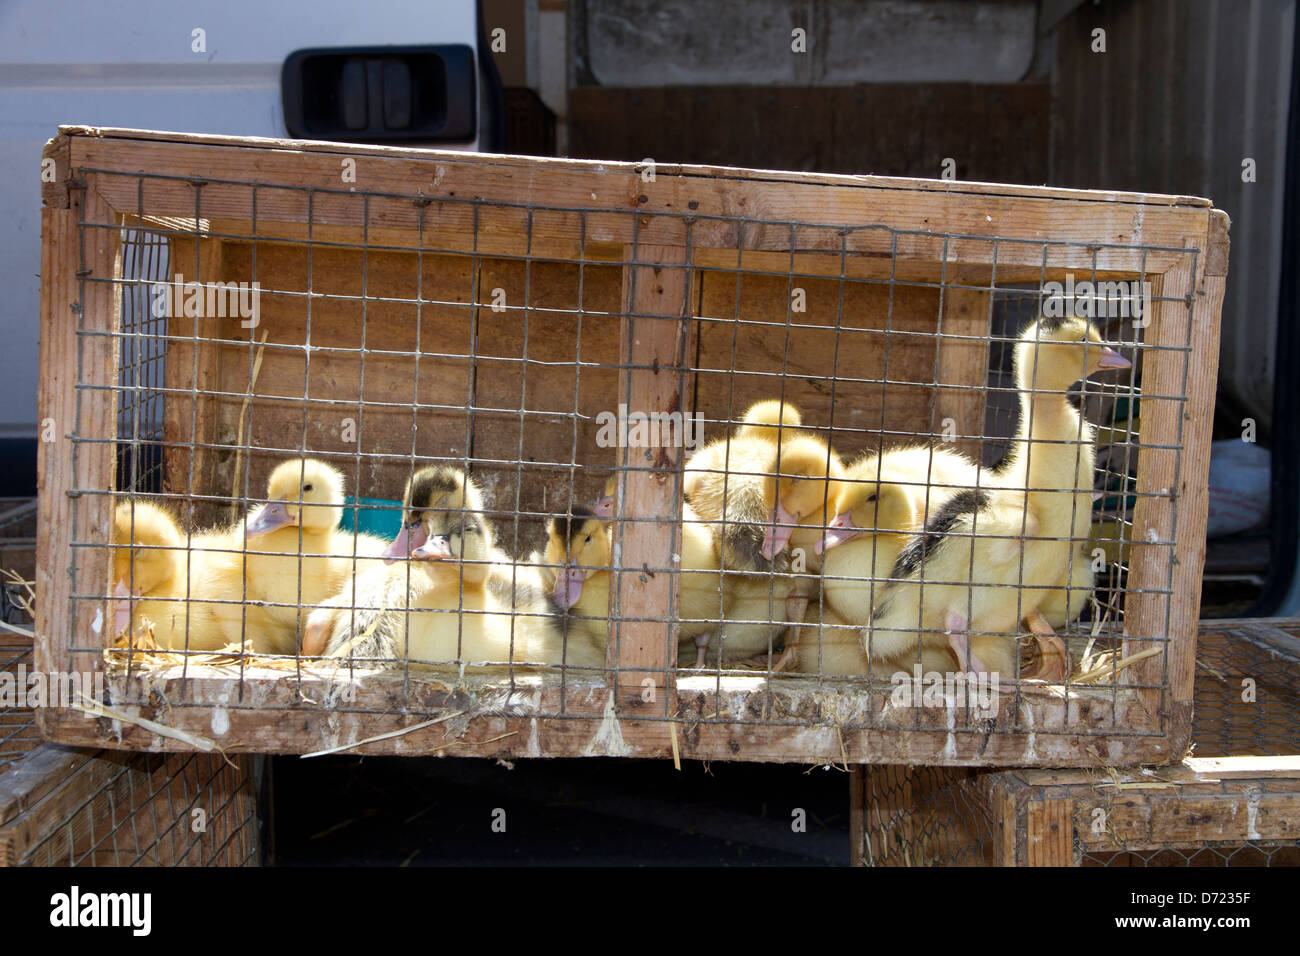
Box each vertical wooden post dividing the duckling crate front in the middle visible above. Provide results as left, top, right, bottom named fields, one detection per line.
left=610, top=243, right=692, bottom=712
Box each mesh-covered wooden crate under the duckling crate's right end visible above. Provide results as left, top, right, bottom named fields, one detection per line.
left=852, top=620, right=1300, bottom=866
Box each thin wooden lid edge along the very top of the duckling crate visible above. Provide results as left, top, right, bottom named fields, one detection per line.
left=59, top=125, right=1210, bottom=207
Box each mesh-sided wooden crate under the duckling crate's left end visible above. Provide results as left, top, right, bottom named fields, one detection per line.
left=0, top=744, right=260, bottom=866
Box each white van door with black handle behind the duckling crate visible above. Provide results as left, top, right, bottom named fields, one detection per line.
left=0, top=0, right=502, bottom=486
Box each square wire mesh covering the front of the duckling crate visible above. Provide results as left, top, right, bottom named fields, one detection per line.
left=53, top=158, right=1200, bottom=754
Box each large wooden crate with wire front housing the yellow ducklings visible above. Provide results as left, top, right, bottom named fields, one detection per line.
left=38, top=127, right=1227, bottom=766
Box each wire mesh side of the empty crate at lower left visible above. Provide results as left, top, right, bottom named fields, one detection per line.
left=18, top=754, right=260, bottom=866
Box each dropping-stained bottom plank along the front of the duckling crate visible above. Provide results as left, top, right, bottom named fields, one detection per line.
left=35, top=665, right=1173, bottom=767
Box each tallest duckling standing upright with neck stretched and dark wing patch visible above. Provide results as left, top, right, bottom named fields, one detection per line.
left=865, top=319, right=1130, bottom=680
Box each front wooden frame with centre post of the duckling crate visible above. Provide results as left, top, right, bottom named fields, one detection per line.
left=36, top=127, right=1227, bottom=766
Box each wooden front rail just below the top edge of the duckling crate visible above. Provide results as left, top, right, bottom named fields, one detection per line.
left=73, top=138, right=1208, bottom=272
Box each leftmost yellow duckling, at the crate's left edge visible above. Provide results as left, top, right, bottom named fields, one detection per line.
left=109, top=499, right=230, bottom=650
